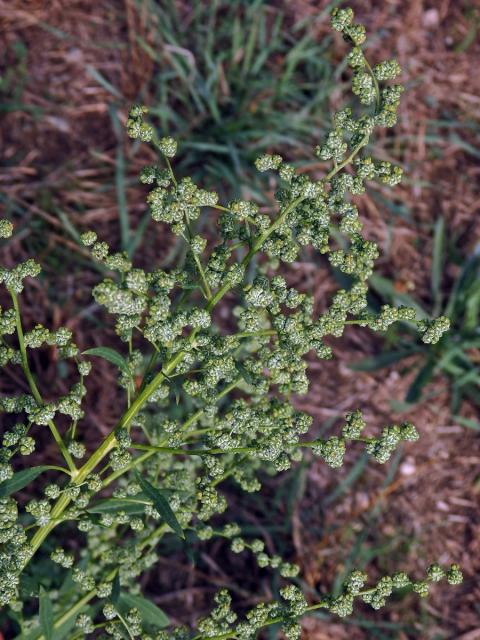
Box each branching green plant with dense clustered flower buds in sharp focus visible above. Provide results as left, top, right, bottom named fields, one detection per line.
left=0, top=9, right=461, bottom=640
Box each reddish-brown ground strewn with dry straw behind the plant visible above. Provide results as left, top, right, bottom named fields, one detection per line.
left=0, top=0, right=480, bottom=640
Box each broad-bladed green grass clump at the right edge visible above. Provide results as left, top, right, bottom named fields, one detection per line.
left=358, top=218, right=480, bottom=418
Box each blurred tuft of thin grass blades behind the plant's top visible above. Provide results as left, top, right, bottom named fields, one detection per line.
left=142, top=0, right=335, bottom=201
